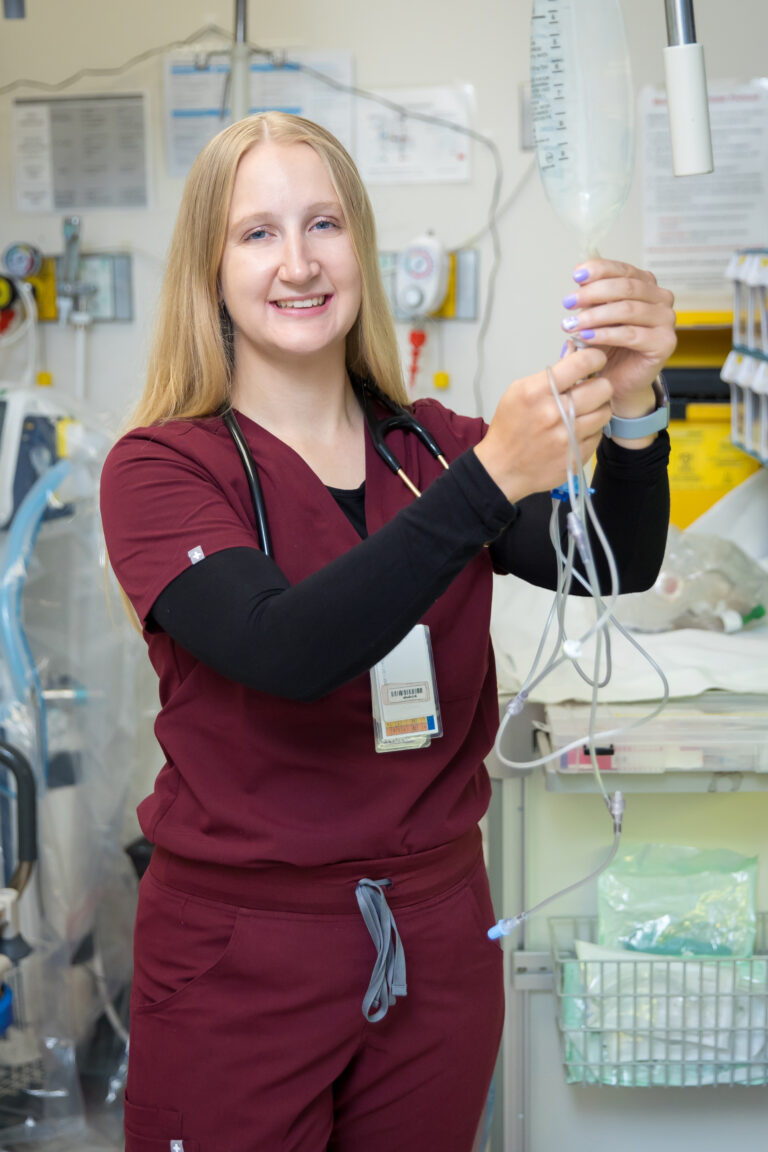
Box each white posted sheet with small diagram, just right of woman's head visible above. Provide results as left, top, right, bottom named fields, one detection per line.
left=356, top=85, right=471, bottom=184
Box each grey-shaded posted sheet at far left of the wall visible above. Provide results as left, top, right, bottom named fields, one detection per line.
left=13, top=94, right=147, bottom=212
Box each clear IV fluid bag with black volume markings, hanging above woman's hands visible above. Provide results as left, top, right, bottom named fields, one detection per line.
left=531, top=0, right=634, bottom=255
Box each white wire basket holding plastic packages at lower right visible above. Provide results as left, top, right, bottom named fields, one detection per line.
left=549, top=912, right=768, bottom=1087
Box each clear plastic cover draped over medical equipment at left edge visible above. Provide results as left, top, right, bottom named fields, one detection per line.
left=0, top=391, right=142, bottom=1149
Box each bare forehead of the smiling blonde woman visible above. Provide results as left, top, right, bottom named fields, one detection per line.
left=226, top=141, right=339, bottom=211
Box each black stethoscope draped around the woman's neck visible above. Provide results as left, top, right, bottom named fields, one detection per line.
left=222, top=374, right=448, bottom=556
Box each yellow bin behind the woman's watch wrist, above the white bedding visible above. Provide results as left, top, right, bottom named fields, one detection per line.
left=669, top=401, right=760, bottom=528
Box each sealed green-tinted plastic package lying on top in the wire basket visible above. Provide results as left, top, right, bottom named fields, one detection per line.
left=598, top=844, right=758, bottom=957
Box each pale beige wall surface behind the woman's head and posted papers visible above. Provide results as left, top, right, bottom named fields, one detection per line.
left=0, top=0, right=768, bottom=423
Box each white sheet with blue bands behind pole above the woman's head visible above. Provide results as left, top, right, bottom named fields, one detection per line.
left=165, top=51, right=352, bottom=176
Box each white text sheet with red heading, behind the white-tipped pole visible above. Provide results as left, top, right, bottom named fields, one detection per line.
left=640, top=79, right=768, bottom=309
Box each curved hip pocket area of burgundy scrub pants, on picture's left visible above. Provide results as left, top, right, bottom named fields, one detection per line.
left=131, top=871, right=237, bottom=1013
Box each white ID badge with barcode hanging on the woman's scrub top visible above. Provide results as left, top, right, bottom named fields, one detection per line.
left=371, top=624, right=442, bottom=752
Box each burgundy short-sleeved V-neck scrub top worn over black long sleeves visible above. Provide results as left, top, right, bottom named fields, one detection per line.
left=101, top=400, right=499, bottom=866
